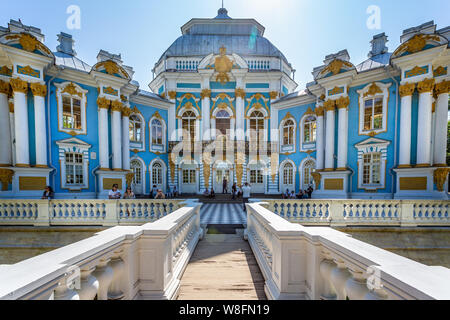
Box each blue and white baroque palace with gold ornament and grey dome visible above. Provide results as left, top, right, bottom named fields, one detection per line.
left=0, top=8, right=450, bottom=199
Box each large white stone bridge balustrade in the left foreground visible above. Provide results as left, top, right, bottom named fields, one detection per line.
left=0, top=201, right=204, bottom=300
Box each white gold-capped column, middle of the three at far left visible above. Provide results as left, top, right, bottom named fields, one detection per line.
left=10, top=79, right=30, bottom=167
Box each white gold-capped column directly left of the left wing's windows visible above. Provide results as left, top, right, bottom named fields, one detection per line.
left=30, top=83, right=48, bottom=168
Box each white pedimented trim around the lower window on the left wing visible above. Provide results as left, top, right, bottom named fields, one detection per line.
left=56, top=138, right=92, bottom=191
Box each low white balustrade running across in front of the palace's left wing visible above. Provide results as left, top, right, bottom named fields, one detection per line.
left=0, top=200, right=184, bottom=226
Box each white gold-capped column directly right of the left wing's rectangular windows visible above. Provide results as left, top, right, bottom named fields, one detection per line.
left=97, top=98, right=111, bottom=170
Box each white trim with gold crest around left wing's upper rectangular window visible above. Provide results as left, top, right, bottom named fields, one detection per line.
left=55, top=82, right=89, bottom=135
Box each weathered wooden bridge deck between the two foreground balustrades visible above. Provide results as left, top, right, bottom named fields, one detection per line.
left=178, top=226, right=266, bottom=301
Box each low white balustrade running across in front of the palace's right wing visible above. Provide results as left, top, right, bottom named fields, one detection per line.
left=264, top=200, right=450, bottom=227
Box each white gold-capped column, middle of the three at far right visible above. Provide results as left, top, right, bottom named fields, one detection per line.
left=417, top=79, right=434, bottom=167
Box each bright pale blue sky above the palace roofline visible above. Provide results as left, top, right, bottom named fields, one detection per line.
left=0, top=0, right=450, bottom=90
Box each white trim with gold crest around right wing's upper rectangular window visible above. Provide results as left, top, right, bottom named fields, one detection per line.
left=357, top=82, right=392, bottom=136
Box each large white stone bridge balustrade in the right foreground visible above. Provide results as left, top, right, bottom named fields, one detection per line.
left=245, top=202, right=450, bottom=300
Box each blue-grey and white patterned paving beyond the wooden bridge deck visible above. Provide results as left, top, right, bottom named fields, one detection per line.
left=200, top=203, right=247, bottom=224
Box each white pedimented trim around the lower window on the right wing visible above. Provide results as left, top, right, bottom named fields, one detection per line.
left=355, top=138, right=391, bottom=191
